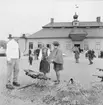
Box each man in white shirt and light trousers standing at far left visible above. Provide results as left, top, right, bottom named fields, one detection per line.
left=6, top=38, right=20, bottom=89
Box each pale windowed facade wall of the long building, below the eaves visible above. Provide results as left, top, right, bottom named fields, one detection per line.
left=19, top=38, right=103, bottom=55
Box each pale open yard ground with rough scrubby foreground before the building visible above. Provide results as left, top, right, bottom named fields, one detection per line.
left=0, top=55, right=103, bottom=105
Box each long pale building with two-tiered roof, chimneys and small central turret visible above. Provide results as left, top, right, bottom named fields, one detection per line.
left=9, top=13, right=103, bottom=54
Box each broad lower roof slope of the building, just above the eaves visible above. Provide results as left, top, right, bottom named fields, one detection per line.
left=27, top=28, right=103, bottom=38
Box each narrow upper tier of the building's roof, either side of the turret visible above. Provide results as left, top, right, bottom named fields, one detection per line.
left=43, top=21, right=103, bottom=28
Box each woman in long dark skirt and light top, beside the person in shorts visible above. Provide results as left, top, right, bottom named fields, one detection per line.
left=39, top=48, right=50, bottom=76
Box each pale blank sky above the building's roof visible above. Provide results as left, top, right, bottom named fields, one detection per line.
left=0, top=0, right=103, bottom=40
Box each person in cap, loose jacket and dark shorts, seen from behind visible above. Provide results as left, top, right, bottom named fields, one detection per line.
left=49, top=41, right=63, bottom=84
